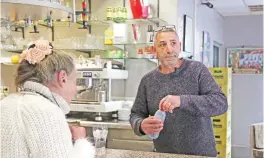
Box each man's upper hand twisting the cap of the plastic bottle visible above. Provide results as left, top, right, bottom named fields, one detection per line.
left=159, top=95, right=181, bottom=113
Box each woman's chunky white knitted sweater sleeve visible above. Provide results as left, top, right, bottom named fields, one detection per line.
left=22, top=105, right=94, bottom=158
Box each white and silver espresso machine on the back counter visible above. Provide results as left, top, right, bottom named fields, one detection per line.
left=70, top=65, right=128, bottom=121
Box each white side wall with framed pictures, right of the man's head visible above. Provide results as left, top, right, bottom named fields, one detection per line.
left=178, top=0, right=225, bottom=66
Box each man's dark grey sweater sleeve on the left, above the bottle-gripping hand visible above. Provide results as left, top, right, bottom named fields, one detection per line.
left=130, top=77, right=149, bottom=136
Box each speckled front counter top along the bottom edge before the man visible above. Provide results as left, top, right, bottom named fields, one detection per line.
left=100, top=149, right=214, bottom=158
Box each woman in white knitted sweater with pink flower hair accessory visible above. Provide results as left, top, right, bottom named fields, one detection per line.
left=1, top=40, right=95, bottom=158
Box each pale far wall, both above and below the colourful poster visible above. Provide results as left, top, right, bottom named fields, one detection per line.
left=224, top=15, right=263, bottom=158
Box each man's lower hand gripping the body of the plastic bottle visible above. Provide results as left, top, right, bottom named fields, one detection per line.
left=140, top=116, right=163, bottom=134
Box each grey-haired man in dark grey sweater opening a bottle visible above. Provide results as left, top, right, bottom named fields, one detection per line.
left=130, top=27, right=228, bottom=156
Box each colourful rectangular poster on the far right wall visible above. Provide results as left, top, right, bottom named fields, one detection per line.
left=227, top=48, right=263, bottom=74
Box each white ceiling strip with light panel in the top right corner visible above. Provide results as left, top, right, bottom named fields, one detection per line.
left=206, top=0, right=263, bottom=16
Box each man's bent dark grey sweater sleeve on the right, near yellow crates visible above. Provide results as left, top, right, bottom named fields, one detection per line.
left=180, top=65, right=228, bottom=117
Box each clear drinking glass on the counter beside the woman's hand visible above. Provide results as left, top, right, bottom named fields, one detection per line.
left=93, top=125, right=108, bottom=156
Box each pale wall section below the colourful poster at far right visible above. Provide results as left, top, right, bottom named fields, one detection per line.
left=231, top=74, right=263, bottom=158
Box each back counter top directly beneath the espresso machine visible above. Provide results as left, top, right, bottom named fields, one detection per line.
left=67, top=119, right=132, bottom=129
